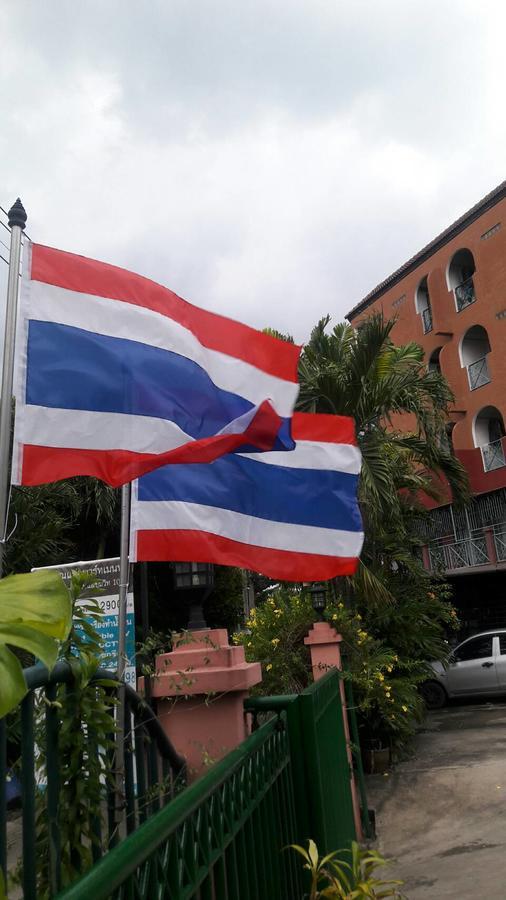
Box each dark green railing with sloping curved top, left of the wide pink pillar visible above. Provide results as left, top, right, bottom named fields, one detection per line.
left=0, top=662, right=186, bottom=900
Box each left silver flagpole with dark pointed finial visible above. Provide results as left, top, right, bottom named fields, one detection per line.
left=0, top=197, right=27, bottom=578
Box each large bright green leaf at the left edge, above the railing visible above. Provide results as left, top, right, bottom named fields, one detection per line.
left=0, top=570, right=72, bottom=718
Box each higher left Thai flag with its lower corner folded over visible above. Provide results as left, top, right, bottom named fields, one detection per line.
left=12, top=244, right=300, bottom=486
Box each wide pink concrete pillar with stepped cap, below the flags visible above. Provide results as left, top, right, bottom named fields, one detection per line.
left=140, top=628, right=262, bottom=780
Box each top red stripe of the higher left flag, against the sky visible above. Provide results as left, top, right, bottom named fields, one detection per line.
left=31, top=244, right=301, bottom=383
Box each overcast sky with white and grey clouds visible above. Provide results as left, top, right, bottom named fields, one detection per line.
left=0, top=0, right=506, bottom=341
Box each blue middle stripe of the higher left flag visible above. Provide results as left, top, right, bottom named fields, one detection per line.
left=26, top=320, right=253, bottom=439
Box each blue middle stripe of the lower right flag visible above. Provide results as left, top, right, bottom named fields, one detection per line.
left=138, top=455, right=362, bottom=531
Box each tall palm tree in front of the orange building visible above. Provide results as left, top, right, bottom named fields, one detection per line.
left=298, top=314, right=469, bottom=599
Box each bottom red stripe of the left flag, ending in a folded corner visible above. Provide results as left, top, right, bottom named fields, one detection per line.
left=20, top=401, right=281, bottom=487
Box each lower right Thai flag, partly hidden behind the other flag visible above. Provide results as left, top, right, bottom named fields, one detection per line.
left=130, top=413, right=363, bottom=581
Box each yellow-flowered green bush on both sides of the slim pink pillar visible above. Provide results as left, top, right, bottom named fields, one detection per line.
left=233, top=579, right=457, bottom=751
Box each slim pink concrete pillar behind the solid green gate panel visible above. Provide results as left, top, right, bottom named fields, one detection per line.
left=304, top=622, right=363, bottom=841
